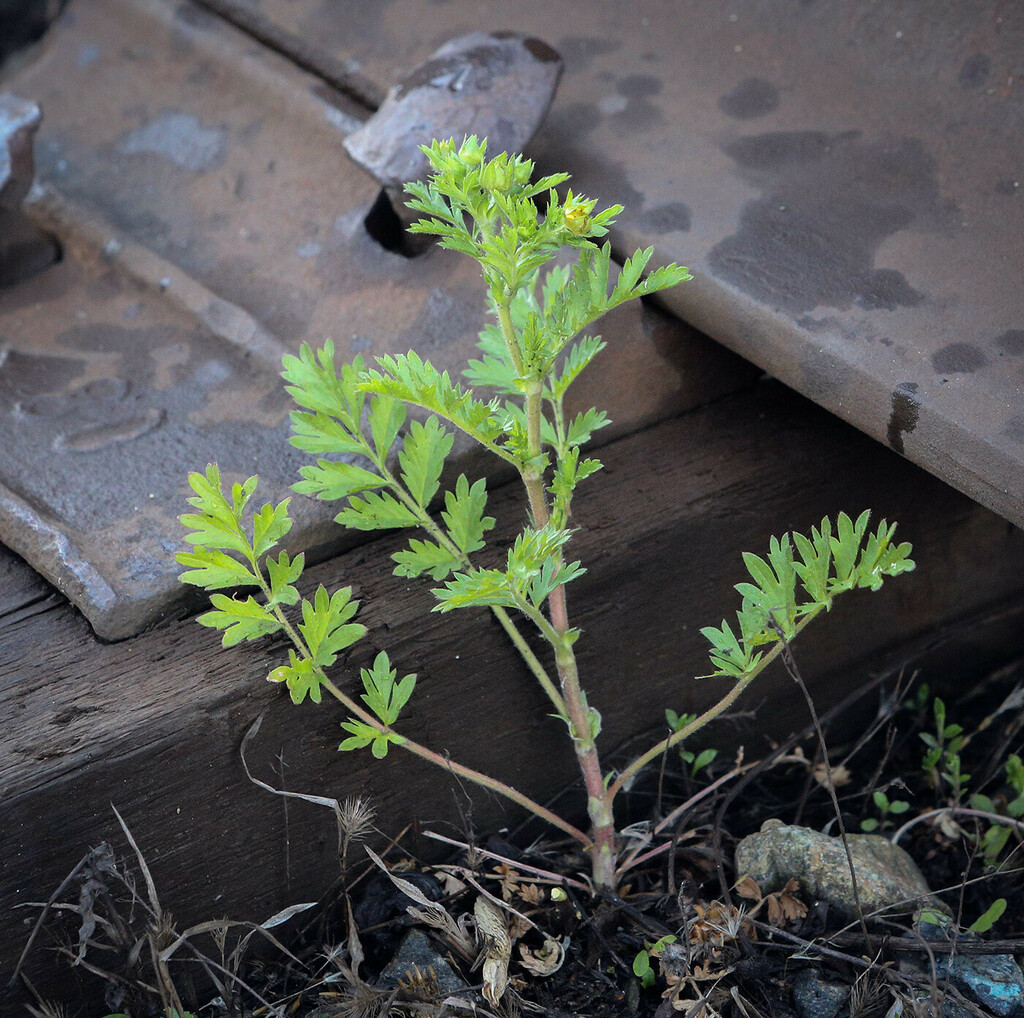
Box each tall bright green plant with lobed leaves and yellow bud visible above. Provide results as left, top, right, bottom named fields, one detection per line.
left=178, top=138, right=913, bottom=888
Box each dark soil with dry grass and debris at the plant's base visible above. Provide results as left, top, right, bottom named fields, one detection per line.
left=18, top=663, right=1024, bottom=1018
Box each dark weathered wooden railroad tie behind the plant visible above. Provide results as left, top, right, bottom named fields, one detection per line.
left=0, top=382, right=1024, bottom=1000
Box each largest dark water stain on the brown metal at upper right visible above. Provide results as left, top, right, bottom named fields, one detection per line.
left=709, top=131, right=948, bottom=314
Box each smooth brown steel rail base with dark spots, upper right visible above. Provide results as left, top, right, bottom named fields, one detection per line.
left=204, top=0, right=1024, bottom=525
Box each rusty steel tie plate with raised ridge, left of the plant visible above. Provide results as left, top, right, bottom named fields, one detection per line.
left=0, top=0, right=742, bottom=638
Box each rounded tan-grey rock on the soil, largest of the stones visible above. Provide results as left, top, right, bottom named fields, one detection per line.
left=736, top=820, right=946, bottom=915
